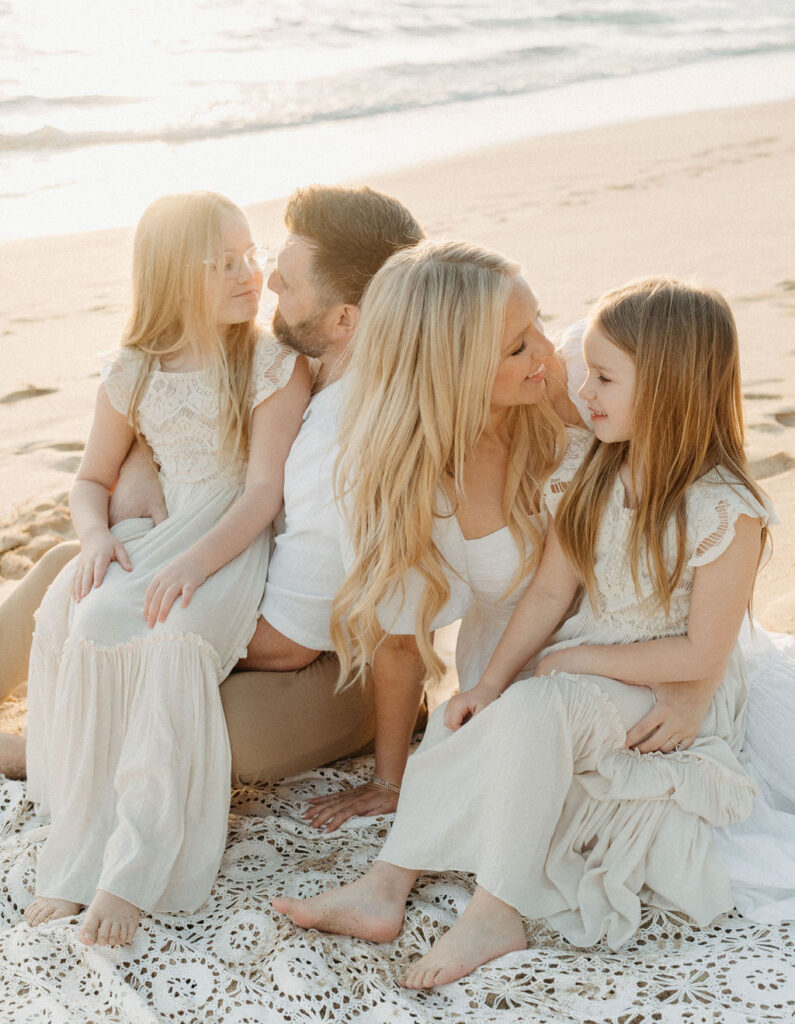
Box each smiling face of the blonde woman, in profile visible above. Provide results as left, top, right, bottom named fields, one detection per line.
left=492, top=274, right=554, bottom=409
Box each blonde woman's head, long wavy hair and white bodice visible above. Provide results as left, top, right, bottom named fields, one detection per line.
left=332, top=242, right=584, bottom=700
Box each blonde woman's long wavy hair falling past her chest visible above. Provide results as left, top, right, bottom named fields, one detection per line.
left=331, top=242, right=564, bottom=682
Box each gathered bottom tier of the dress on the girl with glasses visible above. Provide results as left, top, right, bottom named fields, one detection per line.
left=22, top=631, right=231, bottom=911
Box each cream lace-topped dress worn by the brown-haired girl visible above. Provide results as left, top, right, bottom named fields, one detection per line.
left=379, top=453, right=768, bottom=948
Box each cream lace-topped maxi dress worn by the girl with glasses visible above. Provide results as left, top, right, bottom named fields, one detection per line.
left=28, top=338, right=295, bottom=911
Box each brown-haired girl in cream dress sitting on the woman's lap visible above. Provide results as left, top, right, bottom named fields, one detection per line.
left=276, top=279, right=770, bottom=988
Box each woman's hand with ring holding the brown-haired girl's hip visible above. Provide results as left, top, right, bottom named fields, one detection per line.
left=624, top=679, right=720, bottom=754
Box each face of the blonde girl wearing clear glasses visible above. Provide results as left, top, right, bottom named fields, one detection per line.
left=207, top=210, right=262, bottom=327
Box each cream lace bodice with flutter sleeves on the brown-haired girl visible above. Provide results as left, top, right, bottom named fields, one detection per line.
left=545, top=446, right=776, bottom=642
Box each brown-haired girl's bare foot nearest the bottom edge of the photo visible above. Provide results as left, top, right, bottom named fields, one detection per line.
left=400, top=886, right=528, bottom=988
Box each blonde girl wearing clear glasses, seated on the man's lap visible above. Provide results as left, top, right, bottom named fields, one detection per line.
left=26, top=193, right=309, bottom=945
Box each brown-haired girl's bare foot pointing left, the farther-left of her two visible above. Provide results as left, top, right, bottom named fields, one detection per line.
left=273, top=860, right=419, bottom=942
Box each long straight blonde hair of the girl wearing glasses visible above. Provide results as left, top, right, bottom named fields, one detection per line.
left=122, top=191, right=259, bottom=459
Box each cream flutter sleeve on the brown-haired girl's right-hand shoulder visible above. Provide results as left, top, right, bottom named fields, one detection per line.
left=687, top=469, right=779, bottom=568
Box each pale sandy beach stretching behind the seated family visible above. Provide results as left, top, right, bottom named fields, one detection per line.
left=0, top=100, right=795, bottom=631
